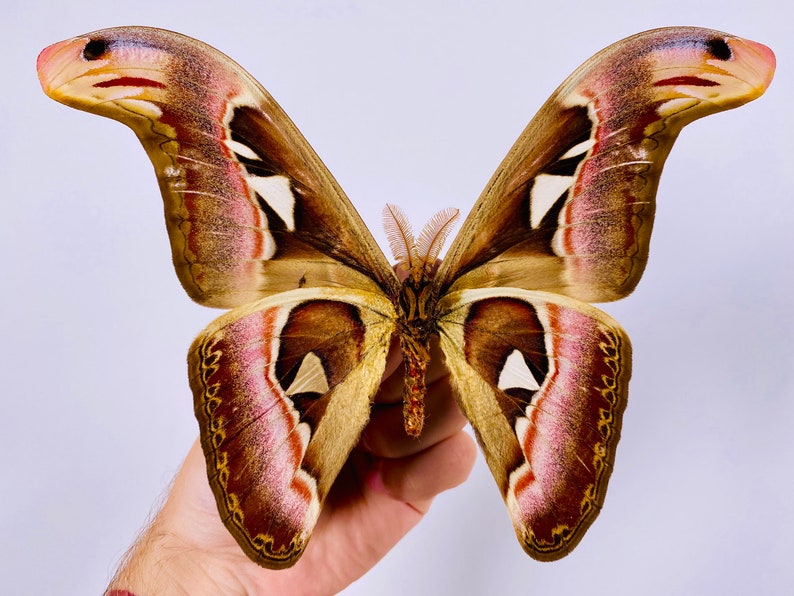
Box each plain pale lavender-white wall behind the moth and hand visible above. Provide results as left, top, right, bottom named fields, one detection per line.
left=0, top=0, right=794, bottom=595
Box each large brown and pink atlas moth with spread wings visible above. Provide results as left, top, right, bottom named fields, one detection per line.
left=38, top=27, right=775, bottom=568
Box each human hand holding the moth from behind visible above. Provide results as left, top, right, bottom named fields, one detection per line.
left=107, top=350, right=476, bottom=596
